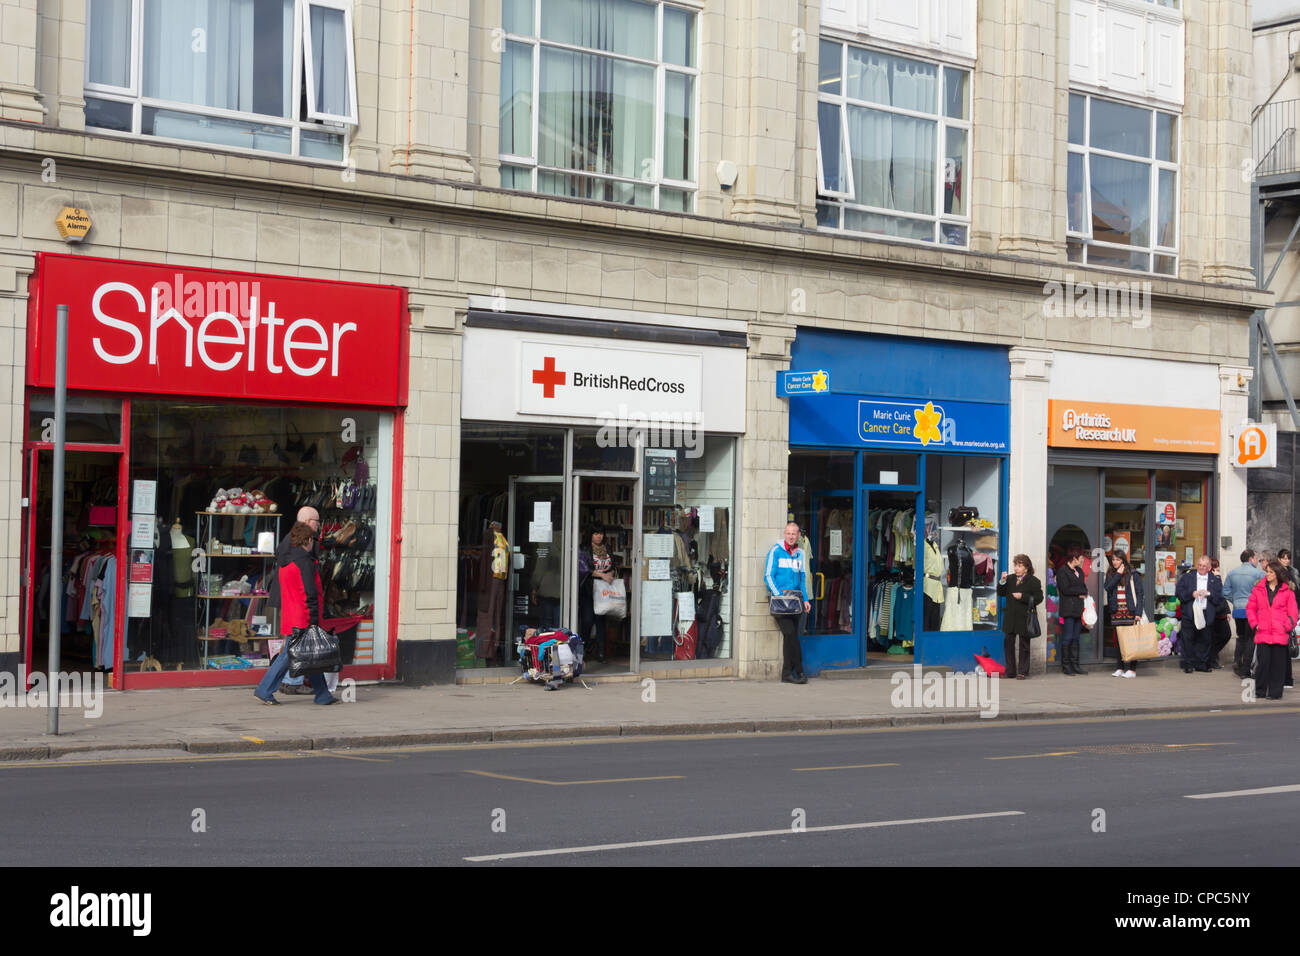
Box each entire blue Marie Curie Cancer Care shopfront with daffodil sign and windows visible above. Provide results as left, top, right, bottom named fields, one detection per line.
left=779, top=329, right=1010, bottom=675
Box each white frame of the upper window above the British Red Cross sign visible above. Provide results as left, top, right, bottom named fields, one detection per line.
left=497, top=0, right=701, bottom=213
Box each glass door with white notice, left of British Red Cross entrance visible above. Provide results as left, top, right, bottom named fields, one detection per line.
left=506, top=477, right=566, bottom=663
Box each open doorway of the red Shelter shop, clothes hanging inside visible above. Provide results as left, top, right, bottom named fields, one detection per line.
left=23, top=447, right=126, bottom=682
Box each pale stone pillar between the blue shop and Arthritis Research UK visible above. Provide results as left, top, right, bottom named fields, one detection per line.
left=1006, top=349, right=1052, bottom=674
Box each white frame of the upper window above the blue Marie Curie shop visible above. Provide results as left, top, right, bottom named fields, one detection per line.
left=816, top=35, right=975, bottom=248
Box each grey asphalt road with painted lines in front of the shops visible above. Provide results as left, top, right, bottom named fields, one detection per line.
left=0, top=713, right=1300, bottom=866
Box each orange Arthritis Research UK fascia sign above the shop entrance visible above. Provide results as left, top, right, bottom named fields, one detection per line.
left=1048, top=399, right=1219, bottom=455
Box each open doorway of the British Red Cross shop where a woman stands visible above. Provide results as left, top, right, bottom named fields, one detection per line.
left=569, top=475, right=639, bottom=672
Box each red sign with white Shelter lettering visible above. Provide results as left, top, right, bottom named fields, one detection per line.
left=27, top=254, right=407, bottom=406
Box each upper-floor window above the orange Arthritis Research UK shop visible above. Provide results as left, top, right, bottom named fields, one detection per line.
left=1066, top=94, right=1178, bottom=276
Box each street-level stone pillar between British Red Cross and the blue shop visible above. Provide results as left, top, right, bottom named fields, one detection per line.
left=732, top=321, right=794, bottom=680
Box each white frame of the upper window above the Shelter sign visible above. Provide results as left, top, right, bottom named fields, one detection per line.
left=82, top=0, right=358, bottom=166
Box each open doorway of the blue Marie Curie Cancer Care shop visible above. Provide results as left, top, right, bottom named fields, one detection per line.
left=863, top=488, right=923, bottom=662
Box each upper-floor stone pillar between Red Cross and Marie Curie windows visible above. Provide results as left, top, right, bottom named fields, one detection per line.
left=722, top=0, right=800, bottom=224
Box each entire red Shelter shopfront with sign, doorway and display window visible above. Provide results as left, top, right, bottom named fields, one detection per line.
left=22, top=254, right=410, bottom=689
